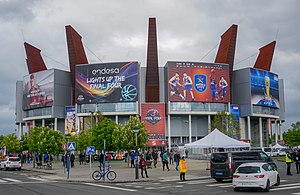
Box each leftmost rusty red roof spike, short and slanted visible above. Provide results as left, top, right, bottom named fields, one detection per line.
left=24, top=42, right=47, bottom=74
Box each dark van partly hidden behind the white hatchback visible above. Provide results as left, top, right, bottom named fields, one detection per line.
left=210, top=151, right=277, bottom=182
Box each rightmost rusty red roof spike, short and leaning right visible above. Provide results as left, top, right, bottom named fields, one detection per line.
left=254, top=41, right=276, bottom=71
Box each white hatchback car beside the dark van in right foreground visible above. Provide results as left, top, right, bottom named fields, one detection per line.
left=232, top=163, right=280, bottom=192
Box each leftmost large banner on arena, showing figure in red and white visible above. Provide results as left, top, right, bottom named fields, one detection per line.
left=23, top=70, right=54, bottom=110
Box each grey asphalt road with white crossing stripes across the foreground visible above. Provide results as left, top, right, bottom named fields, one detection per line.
left=0, top=164, right=300, bottom=195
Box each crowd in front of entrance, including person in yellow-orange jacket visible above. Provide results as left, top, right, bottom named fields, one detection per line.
left=130, top=149, right=187, bottom=181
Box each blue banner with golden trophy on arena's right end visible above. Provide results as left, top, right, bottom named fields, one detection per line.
left=250, top=68, right=280, bottom=108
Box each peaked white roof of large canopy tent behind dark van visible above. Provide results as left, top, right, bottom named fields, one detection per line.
left=185, top=129, right=250, bottom=148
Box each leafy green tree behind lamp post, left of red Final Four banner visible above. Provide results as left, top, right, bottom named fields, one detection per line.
left=113, top=116, right=149, bottom=154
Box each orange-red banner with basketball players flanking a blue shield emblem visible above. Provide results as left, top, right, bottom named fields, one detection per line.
left=167, top=62, right=230, bottom=102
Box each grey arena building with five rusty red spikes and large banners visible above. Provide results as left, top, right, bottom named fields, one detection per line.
left=16, top=18, right=285, bottom=148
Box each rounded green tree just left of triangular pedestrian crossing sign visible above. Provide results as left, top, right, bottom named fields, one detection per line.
left=28, top=127, right=64, bottom=154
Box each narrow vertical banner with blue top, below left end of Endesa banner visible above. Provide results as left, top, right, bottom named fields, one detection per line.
left=65, top=106, right=78, bottom=135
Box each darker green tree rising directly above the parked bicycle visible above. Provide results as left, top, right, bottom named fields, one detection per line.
left=90, top=117, right=116, bottom=151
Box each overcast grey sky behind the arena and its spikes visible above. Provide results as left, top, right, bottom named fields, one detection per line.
left=0, top=0, right=300, bottom=134
